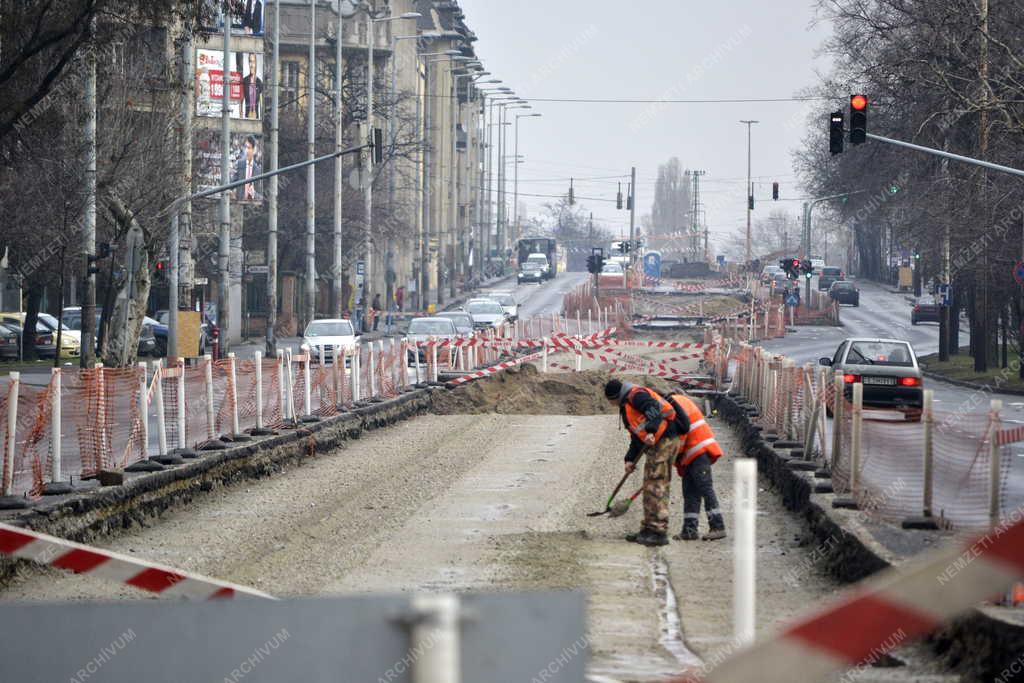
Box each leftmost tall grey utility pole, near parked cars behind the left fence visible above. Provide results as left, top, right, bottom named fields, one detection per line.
left=81, top=17, right=96, bottom=368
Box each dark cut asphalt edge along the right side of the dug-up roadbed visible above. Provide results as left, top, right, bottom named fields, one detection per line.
left=711, top=393, right=1024, bottom=680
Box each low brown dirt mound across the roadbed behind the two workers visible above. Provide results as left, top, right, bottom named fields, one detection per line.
left=433, top=365, right=673, bottom=415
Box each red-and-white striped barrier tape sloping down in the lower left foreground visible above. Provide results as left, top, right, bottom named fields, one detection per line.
left=0, top=524, right=275, bottom=600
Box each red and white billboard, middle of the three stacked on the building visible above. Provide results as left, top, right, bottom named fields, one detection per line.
left=196, top=49, right=263, bottom=121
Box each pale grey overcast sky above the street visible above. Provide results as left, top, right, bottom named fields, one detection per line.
left=460, top=0, right=830, bottom=258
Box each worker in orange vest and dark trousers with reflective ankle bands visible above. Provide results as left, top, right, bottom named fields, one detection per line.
left=669, top=393, right=725, bottom=541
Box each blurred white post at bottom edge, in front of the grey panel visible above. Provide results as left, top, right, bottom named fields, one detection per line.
left=410, top=593, right=462, bottom=683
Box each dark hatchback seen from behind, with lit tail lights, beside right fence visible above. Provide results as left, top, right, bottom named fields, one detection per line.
left=818, top=337, right=924, bottom=421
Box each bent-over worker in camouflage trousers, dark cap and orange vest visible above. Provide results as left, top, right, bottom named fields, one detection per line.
left=604, top=380, right=689, bottom=546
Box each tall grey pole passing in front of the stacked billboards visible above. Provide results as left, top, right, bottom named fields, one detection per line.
left=217, top=9, right=231, bottom=355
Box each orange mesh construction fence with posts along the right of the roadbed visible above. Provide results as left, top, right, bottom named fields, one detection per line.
left=708, top=332, right=1024, bottom=529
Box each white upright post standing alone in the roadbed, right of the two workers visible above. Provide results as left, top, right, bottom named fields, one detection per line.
left=732, top=459, right=758, bottom=645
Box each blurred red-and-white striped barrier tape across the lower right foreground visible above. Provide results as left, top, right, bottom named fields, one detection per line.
left=676, top=513, right=1024, bottom=683
